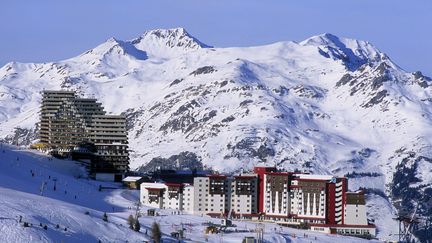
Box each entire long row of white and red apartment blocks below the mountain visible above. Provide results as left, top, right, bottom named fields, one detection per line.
left=141, top=167, right=375, bottom=236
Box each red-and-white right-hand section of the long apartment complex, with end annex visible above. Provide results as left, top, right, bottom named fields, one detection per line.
left=254, top=167, right=376, bottom=236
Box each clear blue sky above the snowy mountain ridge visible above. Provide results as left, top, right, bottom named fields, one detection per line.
left=0, top=0, right=432, bottom=76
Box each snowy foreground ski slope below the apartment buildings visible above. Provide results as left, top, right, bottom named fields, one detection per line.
left=0, top=145, right=380, bottom=243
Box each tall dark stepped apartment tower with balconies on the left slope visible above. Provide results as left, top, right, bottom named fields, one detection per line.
left=39, top=90, right=129, bottom=180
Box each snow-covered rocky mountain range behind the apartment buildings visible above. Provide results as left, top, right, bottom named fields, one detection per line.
left=0, top=28, right=432, bottom=240
